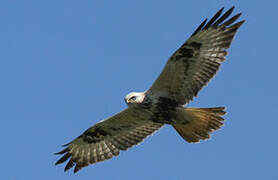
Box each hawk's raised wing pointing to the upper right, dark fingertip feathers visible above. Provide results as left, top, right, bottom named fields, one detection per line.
left=147, top=7, right=244, bottom=104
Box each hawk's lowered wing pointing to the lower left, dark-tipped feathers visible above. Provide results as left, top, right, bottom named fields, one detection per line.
left=56, top=108, right=163, bottom=172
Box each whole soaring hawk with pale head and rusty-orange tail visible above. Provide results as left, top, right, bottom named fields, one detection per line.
left=55, top=6, right=245, bottom=173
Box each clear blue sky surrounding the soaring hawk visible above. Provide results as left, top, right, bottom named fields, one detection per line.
left=0, top=0, right=278, bottom=180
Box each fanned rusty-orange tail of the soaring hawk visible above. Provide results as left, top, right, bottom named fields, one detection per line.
left=173, top=107, right=226, bottom=143
